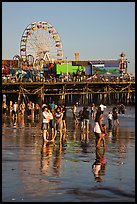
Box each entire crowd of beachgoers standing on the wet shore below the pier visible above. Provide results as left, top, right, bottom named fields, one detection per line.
left=2, top=98, right=122, bottom=148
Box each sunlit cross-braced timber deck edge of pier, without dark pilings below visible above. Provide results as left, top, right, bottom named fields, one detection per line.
left=2, top=81, right=135, bottom=96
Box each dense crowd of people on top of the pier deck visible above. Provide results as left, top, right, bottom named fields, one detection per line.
left=2, top=68, right=135, bottom=83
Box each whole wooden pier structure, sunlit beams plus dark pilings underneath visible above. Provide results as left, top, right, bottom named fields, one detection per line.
left=2, top=81, right=135, bottom=105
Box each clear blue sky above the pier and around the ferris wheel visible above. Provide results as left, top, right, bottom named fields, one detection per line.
left=2, top=1, right=135, bottom=75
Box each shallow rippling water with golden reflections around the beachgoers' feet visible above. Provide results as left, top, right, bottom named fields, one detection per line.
left=2, top=107, right=135, bottom=202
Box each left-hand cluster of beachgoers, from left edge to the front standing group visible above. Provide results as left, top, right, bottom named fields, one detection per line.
left=2, top=101, right=66, bottom=142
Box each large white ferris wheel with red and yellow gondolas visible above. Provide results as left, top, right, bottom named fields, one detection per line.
left=20, top=21, right=63, bottom=62
